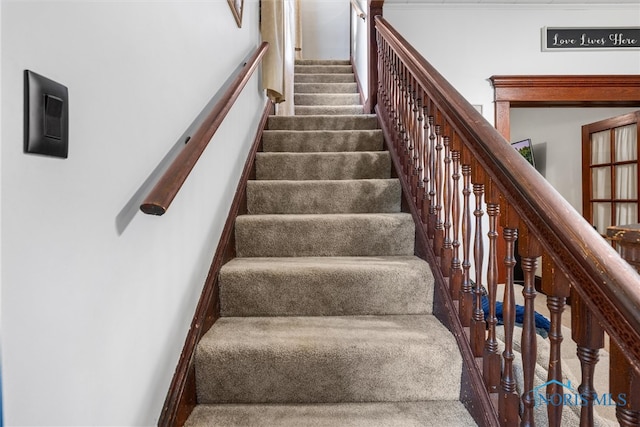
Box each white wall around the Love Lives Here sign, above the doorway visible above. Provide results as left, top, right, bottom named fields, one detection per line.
left=384, top=3, right=640, bottom=123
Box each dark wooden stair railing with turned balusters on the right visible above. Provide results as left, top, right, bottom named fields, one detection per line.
left=370, top=15, right=640, bottom=426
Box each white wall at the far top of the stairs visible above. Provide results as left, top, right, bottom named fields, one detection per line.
left=300, top=0, right=351, bottom=59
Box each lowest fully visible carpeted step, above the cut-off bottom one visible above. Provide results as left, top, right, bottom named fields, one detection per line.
left=196, top=315, right=461, bottom=403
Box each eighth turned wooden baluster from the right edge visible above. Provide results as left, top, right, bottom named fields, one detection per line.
left=459, top=146, right=473, bottom=327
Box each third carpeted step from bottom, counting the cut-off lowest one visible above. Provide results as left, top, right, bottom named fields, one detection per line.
left=219, top=256, right=433, bottom=317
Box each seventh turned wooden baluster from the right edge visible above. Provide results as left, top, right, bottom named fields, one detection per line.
left=469, top=160, right=487, bottom=357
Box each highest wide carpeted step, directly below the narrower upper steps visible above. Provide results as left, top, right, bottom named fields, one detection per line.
left=267, top=114, right=378, bottom=130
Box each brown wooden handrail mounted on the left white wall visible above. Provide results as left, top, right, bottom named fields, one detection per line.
left=140, top=42, right=269, bottom=215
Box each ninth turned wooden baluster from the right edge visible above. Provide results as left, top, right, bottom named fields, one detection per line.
left=449, top=133, right=462, bottom=301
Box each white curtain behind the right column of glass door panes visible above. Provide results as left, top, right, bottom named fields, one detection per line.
left=614, top=124, right=638, bottom=225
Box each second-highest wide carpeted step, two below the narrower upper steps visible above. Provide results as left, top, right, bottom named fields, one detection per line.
left=262, top=129, right=384, bottom=152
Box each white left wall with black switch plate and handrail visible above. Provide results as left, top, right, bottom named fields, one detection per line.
left=1, top=0, right=265, bottom=426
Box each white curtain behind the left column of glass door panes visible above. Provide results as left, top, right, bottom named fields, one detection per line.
left=591, top=130, right=611, bottom=234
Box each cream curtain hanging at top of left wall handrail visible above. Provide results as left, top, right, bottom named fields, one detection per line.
left=260, top=0, right=298, bottom=115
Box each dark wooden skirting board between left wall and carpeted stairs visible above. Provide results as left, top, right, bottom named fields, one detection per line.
left=158, top=101, right=274, bottom=427
